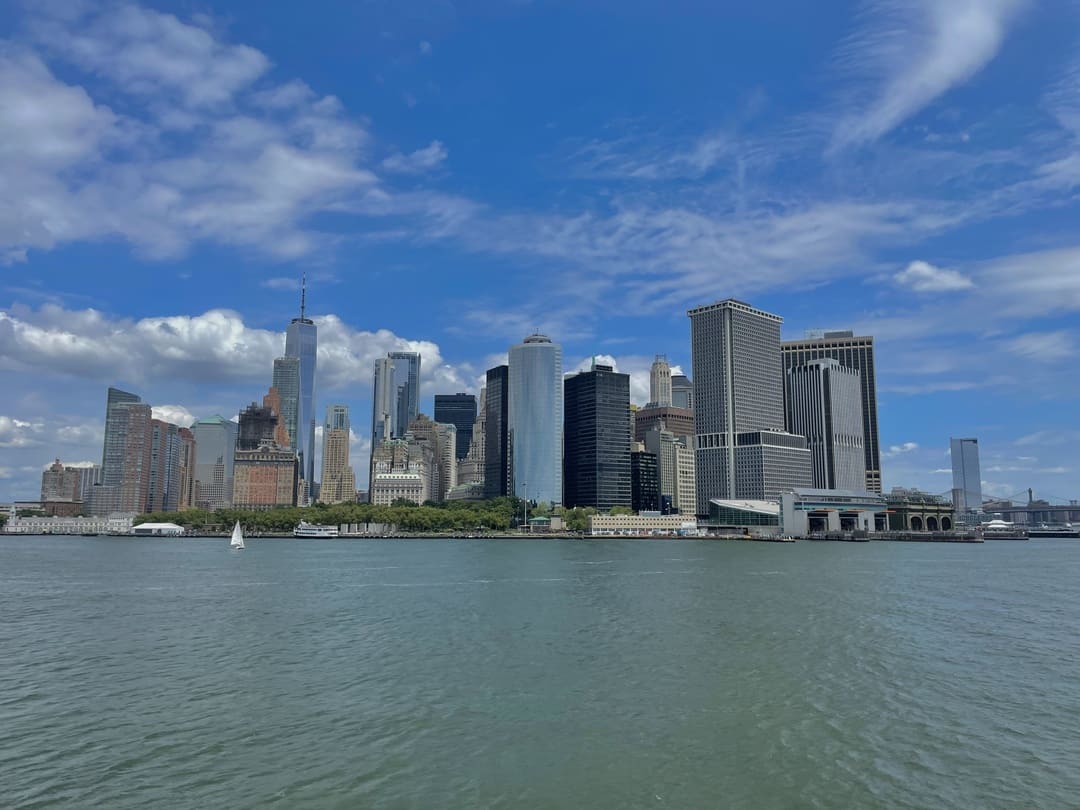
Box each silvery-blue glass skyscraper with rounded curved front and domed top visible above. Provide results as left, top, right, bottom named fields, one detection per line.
left=509, top=335, right=563, bottom=504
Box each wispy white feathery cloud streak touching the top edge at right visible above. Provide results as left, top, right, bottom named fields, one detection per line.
left=833, top=0, right=1026, bottom=147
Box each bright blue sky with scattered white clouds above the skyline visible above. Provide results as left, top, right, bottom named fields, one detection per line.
left=0, top=0, right=1080, bottom=500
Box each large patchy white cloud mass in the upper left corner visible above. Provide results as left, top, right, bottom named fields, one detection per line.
left=0, top=4, right=378, bottom=262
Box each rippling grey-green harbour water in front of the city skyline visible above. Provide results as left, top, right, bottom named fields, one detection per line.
left=0, top=537, right=1080, bottom=809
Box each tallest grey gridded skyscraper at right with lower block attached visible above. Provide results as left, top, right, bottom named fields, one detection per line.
left=687, top=298, right=811, bottom=514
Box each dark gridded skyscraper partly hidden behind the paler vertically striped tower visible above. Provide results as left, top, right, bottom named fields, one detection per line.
left=781, top=332, right=881, bottom=492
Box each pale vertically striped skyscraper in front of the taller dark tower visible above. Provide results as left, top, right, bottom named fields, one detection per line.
left=784, top=359, right=866, bottom=491
